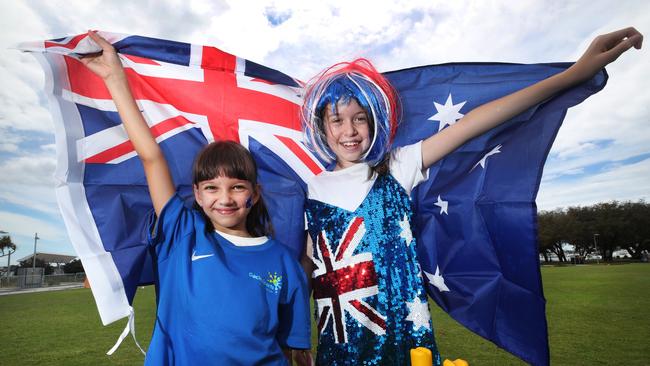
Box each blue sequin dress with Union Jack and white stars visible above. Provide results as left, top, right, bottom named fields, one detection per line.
left=306, top=174, right=440, bottom=366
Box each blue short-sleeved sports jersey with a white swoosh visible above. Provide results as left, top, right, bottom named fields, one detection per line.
left=145, top=195, right=310, bottom=365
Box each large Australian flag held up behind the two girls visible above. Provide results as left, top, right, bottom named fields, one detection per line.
left=21, top=32, right=607, bottom=365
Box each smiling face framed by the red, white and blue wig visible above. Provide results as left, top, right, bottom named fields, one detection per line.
left=323, top=99, right=370, bottom=170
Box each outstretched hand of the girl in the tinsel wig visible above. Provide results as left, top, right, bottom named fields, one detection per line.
left=572, top=27, right=643, bottom=80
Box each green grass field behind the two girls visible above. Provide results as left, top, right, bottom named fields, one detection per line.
left=0, top=264, right=650, bottom=366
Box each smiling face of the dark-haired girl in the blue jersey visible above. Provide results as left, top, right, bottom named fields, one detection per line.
left=194, top=177, right=259, bottom=237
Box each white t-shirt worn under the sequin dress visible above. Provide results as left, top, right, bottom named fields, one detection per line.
left=307, top=141, right=429, bottom=211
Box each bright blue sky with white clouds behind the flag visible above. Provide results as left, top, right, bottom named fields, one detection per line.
left=0, top=0, right=650, bottom=266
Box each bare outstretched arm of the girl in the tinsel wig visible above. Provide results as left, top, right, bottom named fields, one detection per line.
left=422, top=27, right=643, bottom=169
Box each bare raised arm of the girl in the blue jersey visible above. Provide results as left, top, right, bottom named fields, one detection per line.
left=81, top=31, right=175, bottom=215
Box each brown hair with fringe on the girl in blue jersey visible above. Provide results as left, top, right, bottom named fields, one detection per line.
left=192, top=141, right=273, bottom=236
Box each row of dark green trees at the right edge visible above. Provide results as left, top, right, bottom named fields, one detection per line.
left=537, top=200, right=650, bottom=262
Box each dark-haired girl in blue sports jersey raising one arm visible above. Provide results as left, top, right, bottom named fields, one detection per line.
left=83, top=32, right=311, bottom=365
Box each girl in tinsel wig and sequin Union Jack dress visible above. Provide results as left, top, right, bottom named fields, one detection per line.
left=302, top=28, right=642, bottom=365
